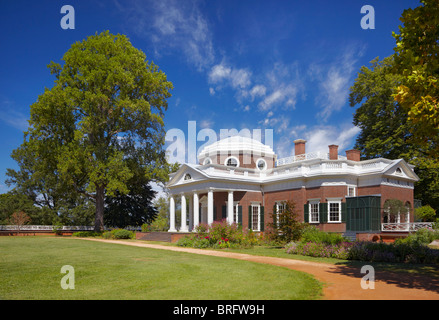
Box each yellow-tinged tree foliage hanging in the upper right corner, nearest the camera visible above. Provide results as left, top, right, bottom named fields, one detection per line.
left=393, top=0, right=439, bottom=159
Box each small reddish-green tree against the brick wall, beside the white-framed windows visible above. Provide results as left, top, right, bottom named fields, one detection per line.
left=268, top=201, right=305, bottom=243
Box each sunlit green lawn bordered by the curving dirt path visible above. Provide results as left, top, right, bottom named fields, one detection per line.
left=0, top=237, right=322, bottom=300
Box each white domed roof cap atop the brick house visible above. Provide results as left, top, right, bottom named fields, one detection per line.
left=198, top=136, right=274, bottom=159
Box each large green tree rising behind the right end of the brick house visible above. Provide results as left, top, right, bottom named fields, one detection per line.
left=349, top=56, right=439, bottom=208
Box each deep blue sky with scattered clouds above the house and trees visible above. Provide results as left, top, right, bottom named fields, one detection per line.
left=0, top=0, right=419, bottom=193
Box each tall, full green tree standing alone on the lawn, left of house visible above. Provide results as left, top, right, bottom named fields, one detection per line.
left=10, top=31, right=172, bottom=231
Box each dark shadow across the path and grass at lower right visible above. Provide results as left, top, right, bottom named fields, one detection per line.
left=331, top=261, right=439, bottom=293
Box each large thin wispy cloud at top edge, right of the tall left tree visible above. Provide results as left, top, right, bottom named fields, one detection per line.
left=115, top=0, right=214, bottom=71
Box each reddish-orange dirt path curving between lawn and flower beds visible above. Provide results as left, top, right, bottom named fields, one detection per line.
left=80, top=238, right=439, bottom=300
